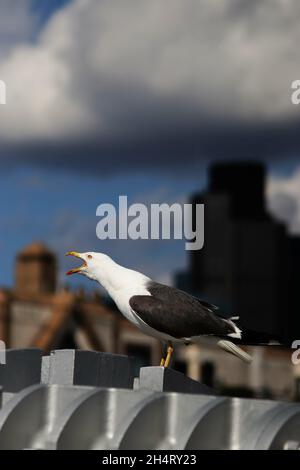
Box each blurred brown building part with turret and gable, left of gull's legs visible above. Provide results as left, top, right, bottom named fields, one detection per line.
left=0, top=243, right=161, bottom=372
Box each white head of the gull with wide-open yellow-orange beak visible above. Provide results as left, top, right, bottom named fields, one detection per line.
left=66, top=251, right=112, bottom=280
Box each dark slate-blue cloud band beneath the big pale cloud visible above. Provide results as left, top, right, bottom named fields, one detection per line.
left=0, top=117, right=300, bottom=174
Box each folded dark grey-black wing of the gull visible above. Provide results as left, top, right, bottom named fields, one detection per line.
left=129, top=282, right=235, bottom=338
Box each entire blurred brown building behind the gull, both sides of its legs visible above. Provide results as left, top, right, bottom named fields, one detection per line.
left=0, top=243, right=296, bottom=398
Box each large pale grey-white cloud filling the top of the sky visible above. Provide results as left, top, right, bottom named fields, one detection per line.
left=0, top=0, right=300, bottom=141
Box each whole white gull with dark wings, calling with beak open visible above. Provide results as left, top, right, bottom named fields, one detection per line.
left=66, top=251, right=252, bottom=367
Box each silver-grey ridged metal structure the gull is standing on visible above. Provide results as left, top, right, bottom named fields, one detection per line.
left=0, top=349, right=300, bottom=450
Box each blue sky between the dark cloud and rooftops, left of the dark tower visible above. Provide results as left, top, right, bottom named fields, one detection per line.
left=0, top=162, right=206, bottom=287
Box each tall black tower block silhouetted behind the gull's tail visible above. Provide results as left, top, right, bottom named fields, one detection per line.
left=189, top=162, right=300, bottom=345
